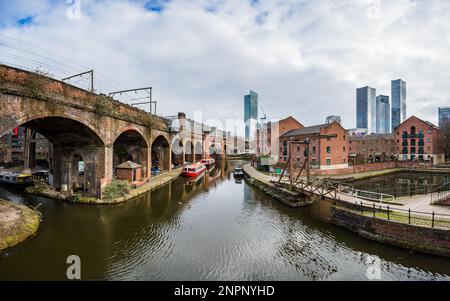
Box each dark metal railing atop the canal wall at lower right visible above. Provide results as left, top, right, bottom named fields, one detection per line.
left=335, top=201, right=450, bottom=230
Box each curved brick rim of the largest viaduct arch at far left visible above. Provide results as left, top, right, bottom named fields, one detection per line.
left=0, top=113, right=107, bottom=144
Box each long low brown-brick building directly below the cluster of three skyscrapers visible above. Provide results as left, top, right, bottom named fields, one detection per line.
left=348, top=134, right=396, bottom=165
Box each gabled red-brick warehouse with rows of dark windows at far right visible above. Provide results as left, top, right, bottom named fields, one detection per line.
left=394, top=116, right=444, bottom=164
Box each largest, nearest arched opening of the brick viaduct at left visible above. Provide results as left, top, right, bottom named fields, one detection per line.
left=14, top=117, right=105, bottom=195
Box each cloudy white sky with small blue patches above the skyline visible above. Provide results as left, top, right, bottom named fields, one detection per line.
left=0, top=0, right=450, bottom=134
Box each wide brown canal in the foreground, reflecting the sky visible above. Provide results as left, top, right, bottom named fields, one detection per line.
left=0, top=163, right=450, bottom=280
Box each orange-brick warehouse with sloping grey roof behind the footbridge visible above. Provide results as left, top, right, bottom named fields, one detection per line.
left=279, top=122, right=349, bottom=170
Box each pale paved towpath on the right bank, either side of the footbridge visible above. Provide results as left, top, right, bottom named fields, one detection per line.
left=243, top=165, right=450, bottom=219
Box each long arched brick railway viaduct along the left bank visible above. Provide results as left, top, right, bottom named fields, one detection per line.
left=0, top=65, right=241, bottom=198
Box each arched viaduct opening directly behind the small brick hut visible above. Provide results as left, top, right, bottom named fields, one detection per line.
left=113, top=130, right=149, bottom=182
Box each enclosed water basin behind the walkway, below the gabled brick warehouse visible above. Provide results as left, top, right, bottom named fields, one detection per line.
left=352, top=172, right=450, bottom=197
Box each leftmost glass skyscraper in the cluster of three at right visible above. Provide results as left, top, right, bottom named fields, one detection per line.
left=356, top=87, right=377, bottom=134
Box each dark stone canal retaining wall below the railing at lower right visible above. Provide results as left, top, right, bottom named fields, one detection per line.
left=331, top=207, right=450, bottom=257
